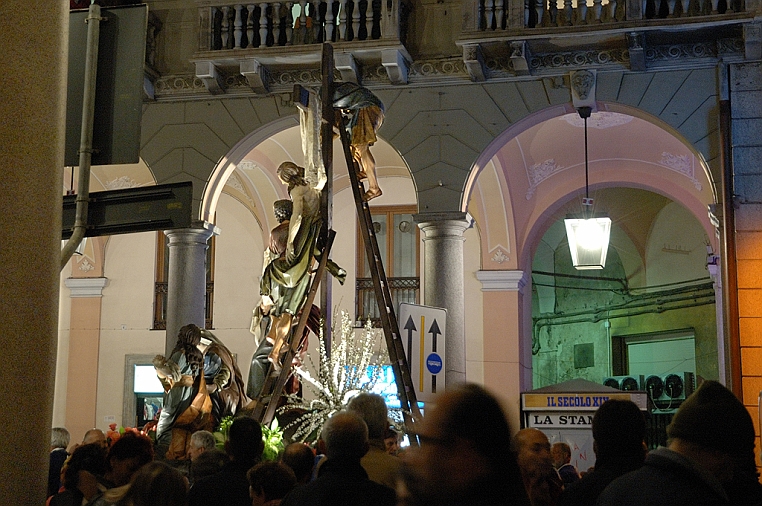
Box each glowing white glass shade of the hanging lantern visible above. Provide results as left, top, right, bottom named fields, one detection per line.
left=564, top=217, right=611, bottom=271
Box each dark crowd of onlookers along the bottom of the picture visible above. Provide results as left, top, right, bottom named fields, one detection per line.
left=48, top=381, right=762, bottom=506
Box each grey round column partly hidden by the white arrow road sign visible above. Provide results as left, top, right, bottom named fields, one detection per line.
left=414, top=212, right=473, bottom=388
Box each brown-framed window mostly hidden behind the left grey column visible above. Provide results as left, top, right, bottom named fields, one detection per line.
left=151, top=231, right=216, bottom=330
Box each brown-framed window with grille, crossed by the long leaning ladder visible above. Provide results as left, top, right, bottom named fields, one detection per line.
left=355, top=206, right=420, bottom=326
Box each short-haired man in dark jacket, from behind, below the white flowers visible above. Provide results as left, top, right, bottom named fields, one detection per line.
left=281, top=411, right=397, bottom=506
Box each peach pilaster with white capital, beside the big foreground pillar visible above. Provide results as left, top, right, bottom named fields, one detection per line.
left=64, top=278, right=108, bottom=441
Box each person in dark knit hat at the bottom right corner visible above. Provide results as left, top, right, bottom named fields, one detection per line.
left=597, top=381, right=762, bottom=506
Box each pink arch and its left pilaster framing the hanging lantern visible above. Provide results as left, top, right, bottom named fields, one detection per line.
left=463, top=96, right=717, bottom=412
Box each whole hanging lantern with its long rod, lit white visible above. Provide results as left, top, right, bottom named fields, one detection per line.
left=564, top=107, right=611, bottom=271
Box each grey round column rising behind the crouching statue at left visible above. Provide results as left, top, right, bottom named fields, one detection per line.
left=164, top=222, right=215, bottom=356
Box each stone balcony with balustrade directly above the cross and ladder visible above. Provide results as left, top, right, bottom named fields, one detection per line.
left=193, top=0, right=412, bottom=94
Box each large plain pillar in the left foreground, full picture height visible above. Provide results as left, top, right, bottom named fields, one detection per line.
left=0, top=0, right=69, bottom=506
